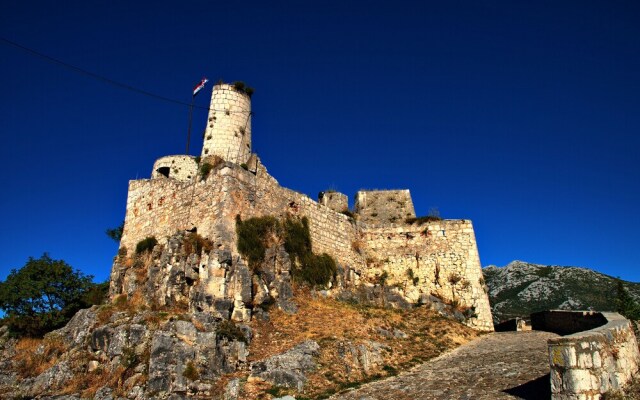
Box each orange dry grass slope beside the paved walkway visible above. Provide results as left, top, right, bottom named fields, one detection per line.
left=244, top=290, right=478, bottom=399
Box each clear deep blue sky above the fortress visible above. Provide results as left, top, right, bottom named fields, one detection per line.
left=0, top=0, right=640, bottom=281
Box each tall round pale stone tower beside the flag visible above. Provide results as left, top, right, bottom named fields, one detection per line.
left=202, top=83, right=251, bottom=164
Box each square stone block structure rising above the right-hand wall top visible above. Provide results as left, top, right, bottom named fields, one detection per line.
left=355, top=189, right=416, bottom=224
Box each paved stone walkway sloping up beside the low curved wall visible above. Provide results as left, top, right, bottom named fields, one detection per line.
left=332, top=331, right=557, bottom=400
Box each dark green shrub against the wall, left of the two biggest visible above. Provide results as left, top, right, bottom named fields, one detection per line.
left=236, top=215, right=280, bottom=270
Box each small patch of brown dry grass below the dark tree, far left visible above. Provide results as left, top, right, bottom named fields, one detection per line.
left=13, top=337, right=67, bottom=378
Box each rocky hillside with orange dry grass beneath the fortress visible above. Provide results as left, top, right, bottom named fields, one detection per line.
left=0, top=232, right=478, bottom=400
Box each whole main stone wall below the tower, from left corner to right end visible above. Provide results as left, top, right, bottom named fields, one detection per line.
left=121, top=162, right=492, bottom=330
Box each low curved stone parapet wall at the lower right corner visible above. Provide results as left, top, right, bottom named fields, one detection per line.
left=549, top=312, right=640, bottom=400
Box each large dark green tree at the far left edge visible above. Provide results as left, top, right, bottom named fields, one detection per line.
left=0, top=253, right=99, bottom=336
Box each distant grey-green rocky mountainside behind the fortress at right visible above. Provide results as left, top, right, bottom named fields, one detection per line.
left=483, top=261, right=640, bottom=322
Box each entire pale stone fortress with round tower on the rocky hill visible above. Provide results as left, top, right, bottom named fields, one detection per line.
left=111, top=80, right=493, bottom=331
